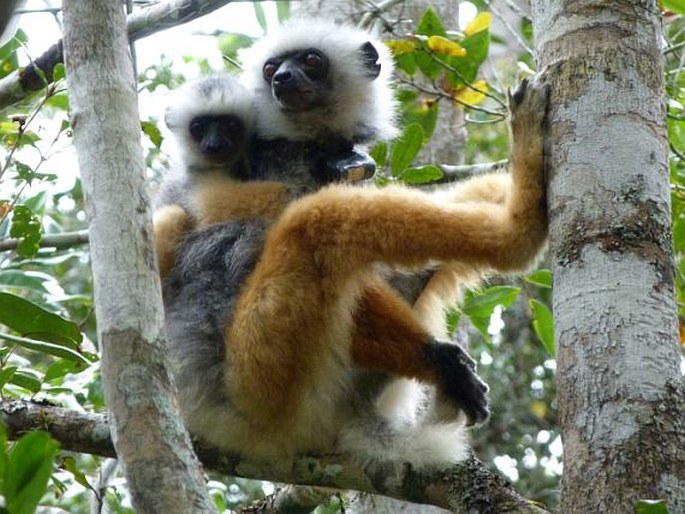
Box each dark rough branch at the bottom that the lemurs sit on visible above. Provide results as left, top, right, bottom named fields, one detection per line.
left=0, top=400, right=546, bottom=514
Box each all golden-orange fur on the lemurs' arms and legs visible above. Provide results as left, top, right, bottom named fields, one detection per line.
left=155, top=77, right=547, bottom=439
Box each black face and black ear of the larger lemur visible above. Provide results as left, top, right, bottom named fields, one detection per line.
left=262, top=43, right=380, bottom=112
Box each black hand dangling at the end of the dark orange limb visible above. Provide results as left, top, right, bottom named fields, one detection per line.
left=424, top=342, right=490, bottom=425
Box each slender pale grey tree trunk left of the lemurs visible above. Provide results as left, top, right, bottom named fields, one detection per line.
left=63, top=0, right=214, bottom=513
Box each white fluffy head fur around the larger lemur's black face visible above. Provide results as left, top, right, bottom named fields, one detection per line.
left=243, top=18, right=396, bottom=142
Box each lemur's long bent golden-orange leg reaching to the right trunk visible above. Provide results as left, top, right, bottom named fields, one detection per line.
left=225, top=77, right=547, bottom=424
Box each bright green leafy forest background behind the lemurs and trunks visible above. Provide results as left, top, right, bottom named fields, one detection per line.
left=0, top=0, right=685, bottom=513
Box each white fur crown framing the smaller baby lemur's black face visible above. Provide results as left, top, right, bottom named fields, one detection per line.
left=164, top=74, right=256, bottom=168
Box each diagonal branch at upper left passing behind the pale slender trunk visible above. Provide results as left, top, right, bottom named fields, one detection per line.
left=0, top=0, right=260, bottom=110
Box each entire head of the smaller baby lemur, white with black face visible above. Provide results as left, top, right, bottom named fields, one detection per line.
left=164, top=74, right=255, bottom=173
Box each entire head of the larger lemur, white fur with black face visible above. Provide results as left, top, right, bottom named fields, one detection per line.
left=243, top=18, right=396, bottom=143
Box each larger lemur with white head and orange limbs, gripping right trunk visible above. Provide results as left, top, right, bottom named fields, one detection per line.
left=155, top=20, right=546, bottom=465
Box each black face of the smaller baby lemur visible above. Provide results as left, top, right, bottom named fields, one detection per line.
left=188, top=114, right=247, bottom=164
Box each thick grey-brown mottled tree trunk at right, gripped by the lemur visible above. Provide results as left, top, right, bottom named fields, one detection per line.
left=533, top=0, right=685, bottom=513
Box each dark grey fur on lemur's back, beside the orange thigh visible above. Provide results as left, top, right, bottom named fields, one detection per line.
left=163, top=220, right=266, bottom=407
